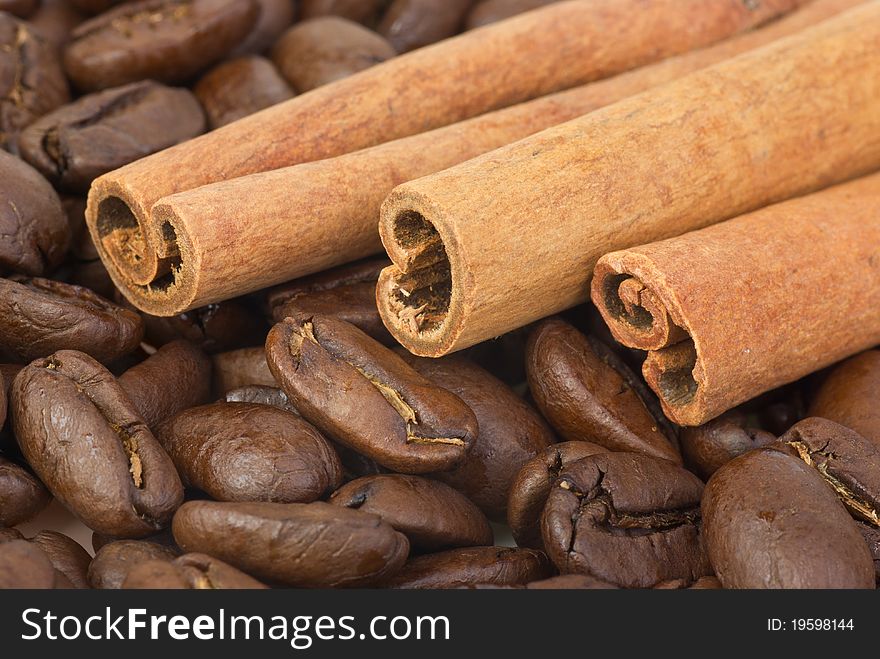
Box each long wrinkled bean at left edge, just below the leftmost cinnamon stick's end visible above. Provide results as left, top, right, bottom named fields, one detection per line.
left=0, top=278, right=143, bottom=363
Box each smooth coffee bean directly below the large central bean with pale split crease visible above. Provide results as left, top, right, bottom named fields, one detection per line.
left=330, top=474, right=493, bottom=551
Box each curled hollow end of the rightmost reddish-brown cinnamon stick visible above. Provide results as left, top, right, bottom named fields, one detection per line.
left=591, top=253, right=706, bottom=426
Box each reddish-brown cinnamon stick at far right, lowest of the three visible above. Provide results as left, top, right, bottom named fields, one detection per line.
left=592, top=174, right=880, bottom=426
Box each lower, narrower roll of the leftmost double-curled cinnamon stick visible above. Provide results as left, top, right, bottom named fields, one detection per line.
left=90, top=0, right=844, bottom=315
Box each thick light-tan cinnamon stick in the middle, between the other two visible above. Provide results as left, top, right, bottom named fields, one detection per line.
left=377, top=2, right=880, bottom=356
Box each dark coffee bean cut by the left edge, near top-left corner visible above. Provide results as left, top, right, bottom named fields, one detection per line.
left=0, top=10, right=70, bottom=152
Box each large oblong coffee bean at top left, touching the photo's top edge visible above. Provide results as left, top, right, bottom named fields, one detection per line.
left=64, top=0, right=260, bottom=91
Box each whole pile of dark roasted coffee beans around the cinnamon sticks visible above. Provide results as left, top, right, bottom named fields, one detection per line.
left=0, top=0, right=880, bottom=589
